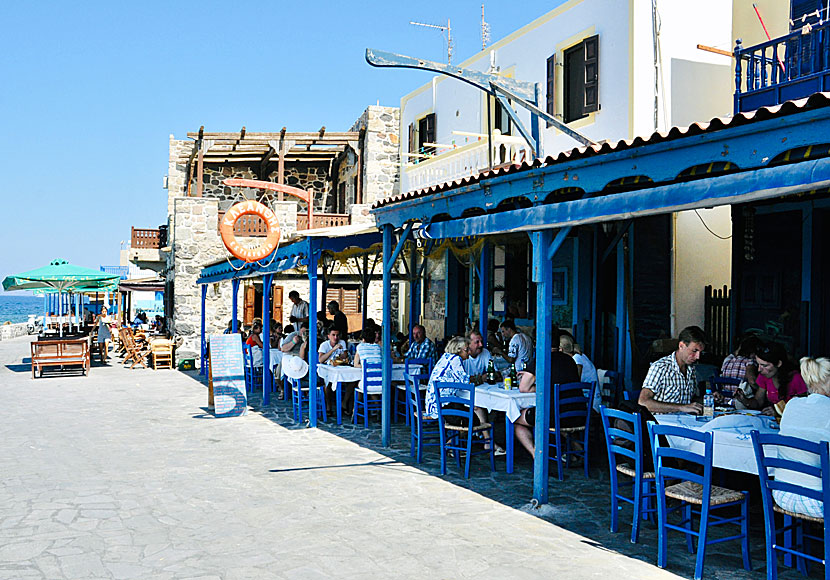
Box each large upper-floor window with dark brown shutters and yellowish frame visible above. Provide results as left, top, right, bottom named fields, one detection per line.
left=560, top=36, right=599, bottom=123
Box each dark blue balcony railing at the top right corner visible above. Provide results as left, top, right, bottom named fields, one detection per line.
left=734, top=22, right=830, bottom=113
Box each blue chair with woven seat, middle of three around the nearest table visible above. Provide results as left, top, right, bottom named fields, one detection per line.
left=648, top=422, right=752, bottom=580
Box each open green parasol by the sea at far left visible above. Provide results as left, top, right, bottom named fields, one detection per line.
left=3, top=260, right=120, bottom=292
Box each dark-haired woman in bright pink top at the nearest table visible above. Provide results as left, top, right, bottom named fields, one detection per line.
left=736, top=342, right=807, bottom=415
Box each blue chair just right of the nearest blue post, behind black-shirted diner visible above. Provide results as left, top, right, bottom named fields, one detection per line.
left=548, top=383, right=597, bottom=481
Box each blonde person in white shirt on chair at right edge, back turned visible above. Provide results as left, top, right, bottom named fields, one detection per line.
left=762, top=357, right=830, bottom=518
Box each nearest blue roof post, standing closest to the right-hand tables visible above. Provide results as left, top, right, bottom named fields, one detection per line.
left=531, top=230, right=553, bottom=504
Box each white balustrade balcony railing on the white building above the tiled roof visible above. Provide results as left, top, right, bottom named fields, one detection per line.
left=404, top=131, right=533, bottom=191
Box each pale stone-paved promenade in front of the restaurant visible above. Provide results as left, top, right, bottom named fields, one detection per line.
left=0, top=338, right=812, bottom=579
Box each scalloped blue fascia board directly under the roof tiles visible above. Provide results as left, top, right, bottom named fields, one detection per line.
left=373, top=107, right=830, bottom=227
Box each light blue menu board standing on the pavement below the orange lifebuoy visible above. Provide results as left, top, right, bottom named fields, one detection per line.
left=208, top=334, right=248, bottom=417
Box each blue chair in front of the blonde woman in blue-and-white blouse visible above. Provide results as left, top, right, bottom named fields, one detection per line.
left=435, top=381, right=496, bottom=478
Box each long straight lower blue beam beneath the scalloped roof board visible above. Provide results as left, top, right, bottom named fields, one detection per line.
left=416, top=158, right=830, bottom=239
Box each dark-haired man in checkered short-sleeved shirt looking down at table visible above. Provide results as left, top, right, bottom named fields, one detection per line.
left=638, top=326, right=706, bottom=415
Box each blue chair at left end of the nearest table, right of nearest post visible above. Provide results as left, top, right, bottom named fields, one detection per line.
left=599, top=405, right=657, bottom=544
